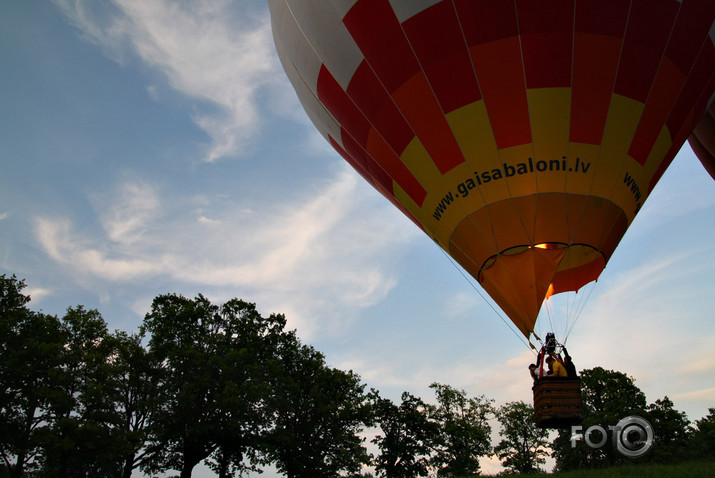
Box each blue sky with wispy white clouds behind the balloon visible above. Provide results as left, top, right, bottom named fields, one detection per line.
left=0, top=0, right=715, bottom=478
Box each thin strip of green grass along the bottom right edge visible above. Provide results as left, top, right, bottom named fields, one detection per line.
left=462, top=461, right=715, bottom=478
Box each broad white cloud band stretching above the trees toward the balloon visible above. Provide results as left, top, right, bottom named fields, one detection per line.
left=34, top=166, right=415, bottom=336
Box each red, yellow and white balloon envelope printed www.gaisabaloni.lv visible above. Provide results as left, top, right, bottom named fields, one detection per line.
left=269, top=0, right=715, bottom=426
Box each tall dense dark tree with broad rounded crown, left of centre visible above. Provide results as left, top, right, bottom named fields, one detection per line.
left=142, top=294, right=285, bottom=478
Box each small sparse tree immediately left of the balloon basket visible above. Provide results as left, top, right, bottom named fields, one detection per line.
left=494, top=401, right=549, bottom=473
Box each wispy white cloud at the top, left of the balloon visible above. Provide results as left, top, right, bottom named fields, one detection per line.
left=57, top=0, right=285, bottom=161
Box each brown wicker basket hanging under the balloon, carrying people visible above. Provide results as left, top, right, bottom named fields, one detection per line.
left=532, top=377, right=583, bottom=428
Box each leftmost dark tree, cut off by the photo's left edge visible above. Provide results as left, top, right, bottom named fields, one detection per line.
left=0, top=275, right=64, bottom=477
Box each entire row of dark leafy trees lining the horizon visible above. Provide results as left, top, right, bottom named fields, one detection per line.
left=0, top=275, right=715, bottom=478
